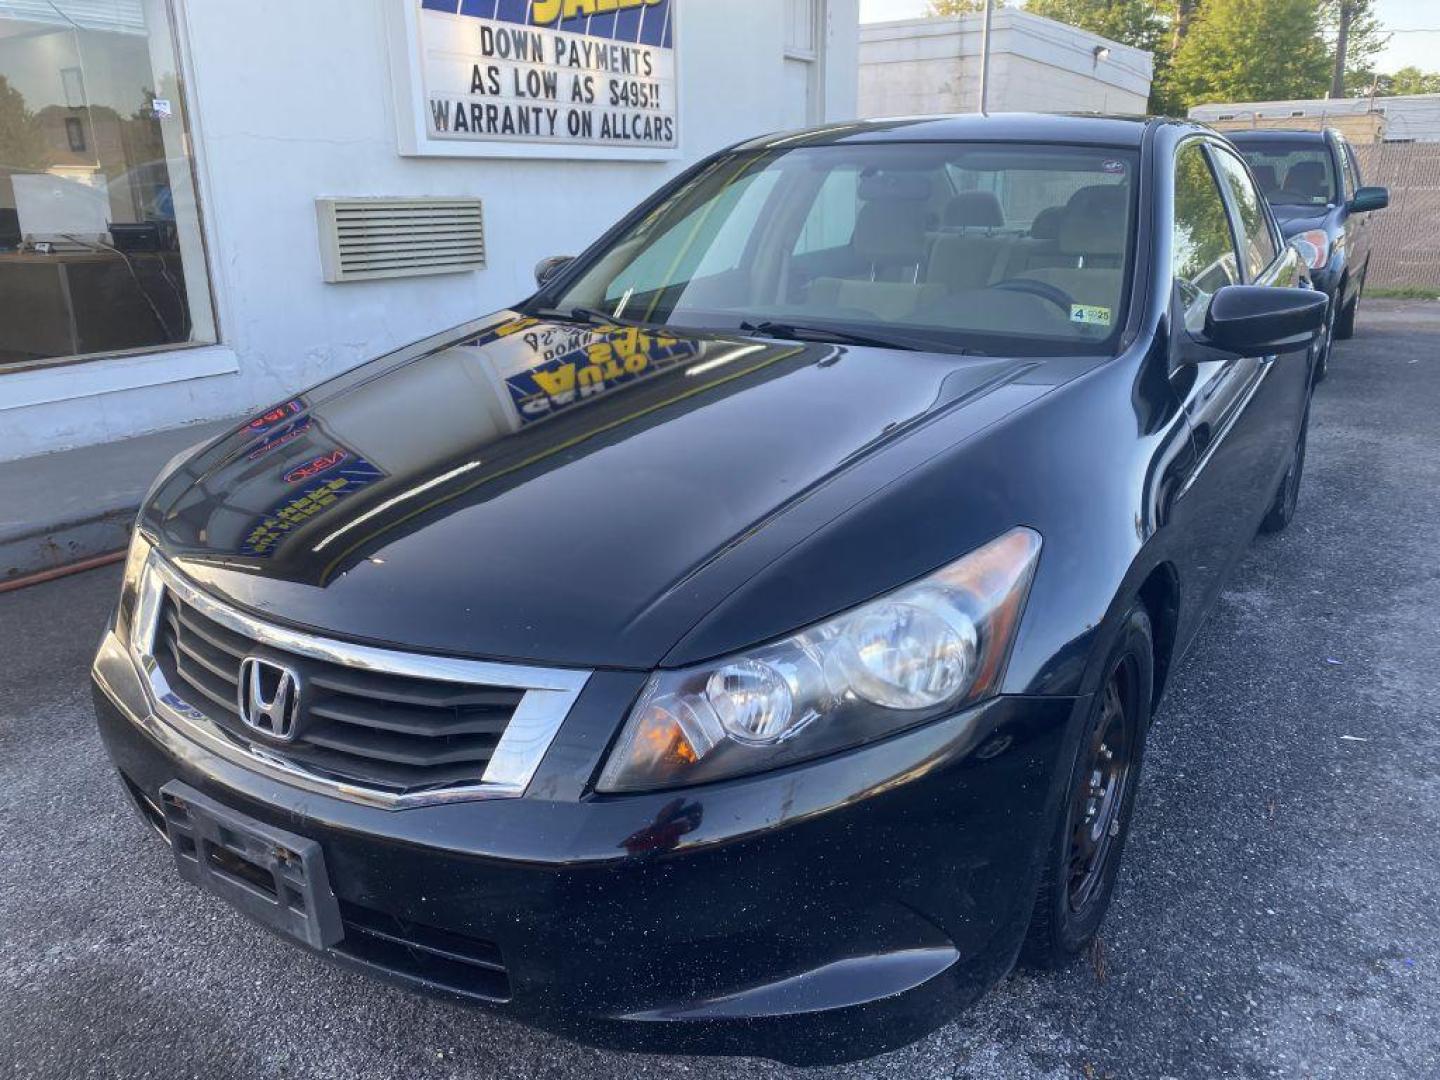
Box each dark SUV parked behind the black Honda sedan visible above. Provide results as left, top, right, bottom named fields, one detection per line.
left=1225, top=128, right=1390, bottom=379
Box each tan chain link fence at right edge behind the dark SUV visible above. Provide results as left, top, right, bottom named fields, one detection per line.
left=1355, top=143, right=1440, bottom=294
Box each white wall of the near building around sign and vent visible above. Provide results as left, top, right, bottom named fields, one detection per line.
left=0, top=0, right=858, bottom=459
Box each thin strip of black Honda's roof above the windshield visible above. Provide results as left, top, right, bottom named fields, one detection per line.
left=734, top=112, right=1169, bottom=150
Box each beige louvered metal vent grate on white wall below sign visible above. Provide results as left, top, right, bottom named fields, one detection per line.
left=315, top=199, right=485, bottom=282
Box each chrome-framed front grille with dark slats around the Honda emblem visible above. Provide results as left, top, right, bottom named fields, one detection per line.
left=135, top=557, right=588, bottom=806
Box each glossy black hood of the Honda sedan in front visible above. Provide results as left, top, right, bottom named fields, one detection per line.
left=143, top=312, right=1094, bottom=668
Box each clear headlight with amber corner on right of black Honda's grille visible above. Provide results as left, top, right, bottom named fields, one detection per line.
left=599, top=528, right=1040, bottom=792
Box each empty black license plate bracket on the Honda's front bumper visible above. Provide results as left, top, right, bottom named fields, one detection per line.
left=160, top=780, right=344, bottom=949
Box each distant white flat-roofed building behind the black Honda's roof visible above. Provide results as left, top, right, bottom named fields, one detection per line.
left=860, top=9, right=1153, bottom=117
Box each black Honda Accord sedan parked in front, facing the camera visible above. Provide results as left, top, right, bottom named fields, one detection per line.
left=94, top=115, right=1325, bottom=1061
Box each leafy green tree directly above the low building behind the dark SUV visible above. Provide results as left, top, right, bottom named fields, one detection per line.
left=1171, top=0, right=1331, bottom=108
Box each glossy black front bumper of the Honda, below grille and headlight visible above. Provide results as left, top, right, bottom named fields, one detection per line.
left=94, top=635, right=1083, bottom=1063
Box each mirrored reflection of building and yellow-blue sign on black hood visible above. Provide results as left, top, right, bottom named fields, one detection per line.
left=158, top=317, right=817, bottom=580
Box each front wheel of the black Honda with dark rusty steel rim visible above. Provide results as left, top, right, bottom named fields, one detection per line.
left=1021, top=603, right=1155, bottom=971
